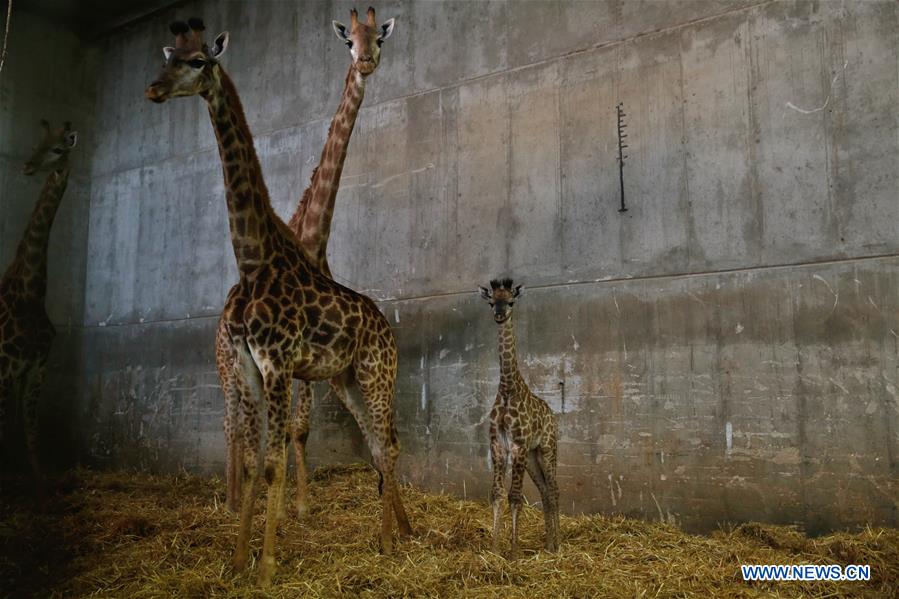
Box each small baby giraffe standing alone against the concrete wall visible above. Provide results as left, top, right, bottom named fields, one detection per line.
left=480, top=279, right=559, bottom=558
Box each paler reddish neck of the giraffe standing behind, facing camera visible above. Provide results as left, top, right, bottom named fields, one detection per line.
left=288, top=65, right=365, bottom=275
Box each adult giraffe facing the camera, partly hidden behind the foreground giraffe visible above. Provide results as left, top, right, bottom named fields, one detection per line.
left=216, top=7, right=395, bottom=515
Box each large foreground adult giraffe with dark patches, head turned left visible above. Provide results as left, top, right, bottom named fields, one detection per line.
left=146, top=19, right=411, bottom=586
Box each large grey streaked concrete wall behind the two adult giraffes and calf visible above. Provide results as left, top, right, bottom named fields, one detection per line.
left=12, top=1, right=899, bottom=531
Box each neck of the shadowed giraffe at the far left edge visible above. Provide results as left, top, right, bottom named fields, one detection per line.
left=3, top=166, right=69, bottom=298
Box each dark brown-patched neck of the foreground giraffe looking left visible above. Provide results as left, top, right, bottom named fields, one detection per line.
left=203, top=66, right=279, bottom=278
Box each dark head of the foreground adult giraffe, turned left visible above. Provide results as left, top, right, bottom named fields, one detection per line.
left=145, top=17, right=228, bottom=103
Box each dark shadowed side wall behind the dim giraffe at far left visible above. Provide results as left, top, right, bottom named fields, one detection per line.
left=0, top=7, right=98, bottom=465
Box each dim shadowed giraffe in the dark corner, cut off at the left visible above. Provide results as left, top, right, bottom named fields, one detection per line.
left=0, top=120, right=78, bottom=496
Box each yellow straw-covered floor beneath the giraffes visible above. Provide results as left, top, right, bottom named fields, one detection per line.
left=0, top=466, right=899, bottom=598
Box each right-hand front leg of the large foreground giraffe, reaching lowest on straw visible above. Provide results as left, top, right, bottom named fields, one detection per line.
left=259, top=366, right=292, bottom=587
